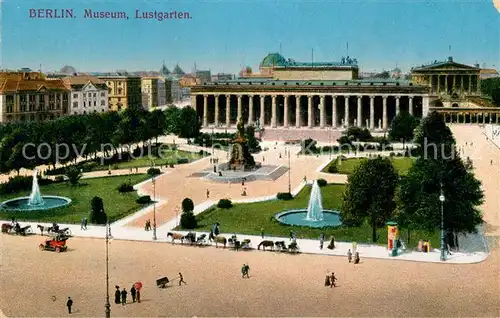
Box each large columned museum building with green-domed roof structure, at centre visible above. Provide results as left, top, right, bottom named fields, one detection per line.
left=191, top=53, right=429, bottom=130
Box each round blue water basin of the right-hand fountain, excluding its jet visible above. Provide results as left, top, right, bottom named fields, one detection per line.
left=274, top=209, right=342, bottom=228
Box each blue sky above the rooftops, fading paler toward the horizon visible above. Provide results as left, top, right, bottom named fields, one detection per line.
left=0, top=0, right=500, bottom=73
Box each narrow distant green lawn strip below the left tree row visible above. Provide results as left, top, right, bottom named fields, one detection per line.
left=93, top=150, right=202, bottom=170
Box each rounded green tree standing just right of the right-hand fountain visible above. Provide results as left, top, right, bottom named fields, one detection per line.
left=341, top=157, right=399, bottom=242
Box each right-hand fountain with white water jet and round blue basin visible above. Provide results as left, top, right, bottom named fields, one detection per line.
left=275, top=180, right=342, bottom=228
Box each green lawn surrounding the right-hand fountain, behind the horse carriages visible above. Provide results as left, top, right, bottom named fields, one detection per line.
left=184, top=184, right=439, bottom=244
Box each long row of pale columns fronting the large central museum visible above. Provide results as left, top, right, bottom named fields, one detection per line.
left=191, top=93, right=429, bottom=130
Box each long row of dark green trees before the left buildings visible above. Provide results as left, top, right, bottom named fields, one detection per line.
left=0, top=107, right=201, bottom=173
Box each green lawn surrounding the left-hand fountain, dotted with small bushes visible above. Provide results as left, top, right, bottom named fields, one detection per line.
left=0, top=174, right=148, bottom=223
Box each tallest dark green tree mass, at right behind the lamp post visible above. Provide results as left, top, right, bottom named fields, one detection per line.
left=396, top=113, right=483, bottom=241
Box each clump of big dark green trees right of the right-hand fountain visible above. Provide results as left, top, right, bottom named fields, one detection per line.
left=341, top=112, right=483, bottom=242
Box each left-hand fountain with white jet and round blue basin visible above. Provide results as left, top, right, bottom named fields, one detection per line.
left=0, top=169, right=71, bottom=211
